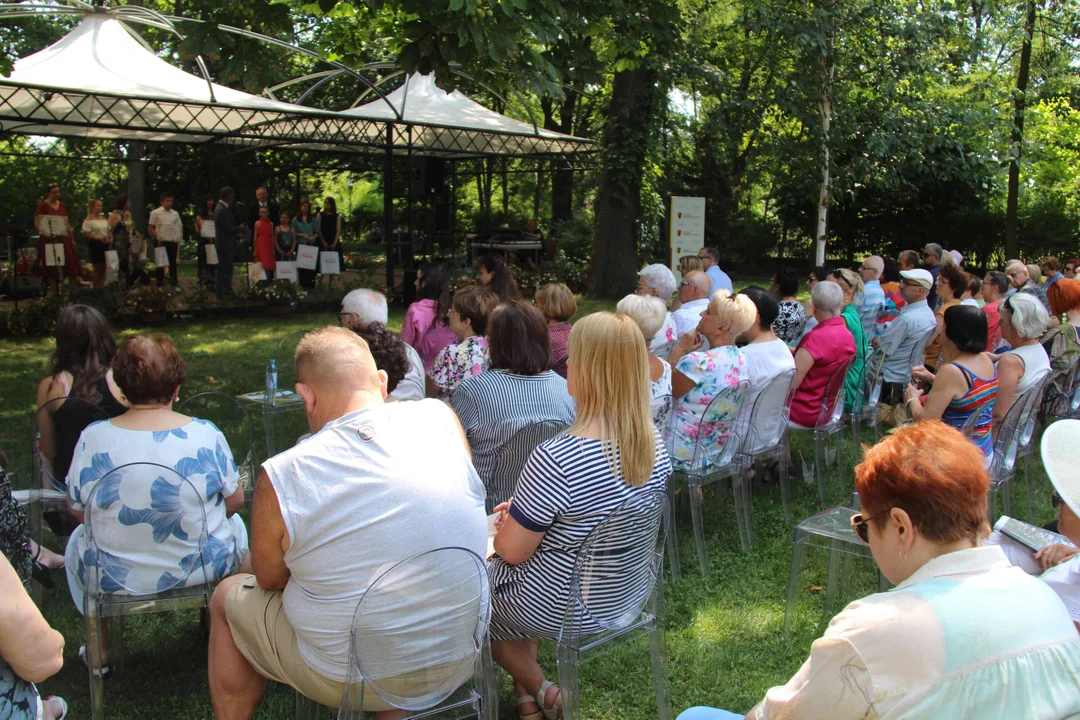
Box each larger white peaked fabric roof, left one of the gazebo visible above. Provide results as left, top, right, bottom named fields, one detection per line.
left=0, top=14, right=336, bottom=141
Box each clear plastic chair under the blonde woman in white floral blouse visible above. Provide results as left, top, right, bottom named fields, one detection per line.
left=667, top=380, right=752, bottom=581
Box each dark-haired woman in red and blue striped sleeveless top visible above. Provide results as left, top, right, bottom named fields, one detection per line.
left=905, top=305, right=998, bottom=456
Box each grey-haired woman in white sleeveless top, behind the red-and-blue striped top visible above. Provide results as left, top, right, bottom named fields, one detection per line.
left=994, top=293, right=1050, bottom=436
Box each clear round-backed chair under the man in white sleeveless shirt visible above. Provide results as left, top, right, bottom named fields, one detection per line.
left=338, top=547, right=499, bottom=720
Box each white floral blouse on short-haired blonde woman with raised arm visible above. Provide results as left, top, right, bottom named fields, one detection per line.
left=671, top=345, right=750, bottom=471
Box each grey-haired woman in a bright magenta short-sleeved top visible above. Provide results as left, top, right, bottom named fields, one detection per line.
left=789, top=281, right=855, bottom=429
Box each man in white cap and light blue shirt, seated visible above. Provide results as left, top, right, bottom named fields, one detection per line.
left=876, top=268, right=937, bottom=402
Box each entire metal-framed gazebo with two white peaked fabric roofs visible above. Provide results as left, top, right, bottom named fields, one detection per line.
left=0, top=0, right=592, bottom=287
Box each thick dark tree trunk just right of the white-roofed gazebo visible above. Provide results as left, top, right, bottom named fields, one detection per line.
left=592, top=68, right=657, bottom=299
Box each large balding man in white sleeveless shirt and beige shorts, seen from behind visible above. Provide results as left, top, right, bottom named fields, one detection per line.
left=210, top=327, right=487, bottom=719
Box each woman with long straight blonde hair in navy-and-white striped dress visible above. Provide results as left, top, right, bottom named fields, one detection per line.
left=488, top=312, right=672, bottom=720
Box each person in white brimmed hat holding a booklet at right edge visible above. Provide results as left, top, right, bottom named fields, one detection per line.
left=986, top=420, right=1080, bottom=630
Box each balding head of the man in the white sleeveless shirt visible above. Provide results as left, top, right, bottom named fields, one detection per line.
left=296, top=327, right=380, bottom=395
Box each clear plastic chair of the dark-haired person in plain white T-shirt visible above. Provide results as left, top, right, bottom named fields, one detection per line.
left=740, top=368, right=795, bottom=533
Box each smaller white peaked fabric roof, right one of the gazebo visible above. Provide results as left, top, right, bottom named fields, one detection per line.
left=282, top=73, right=592, bottom=158
